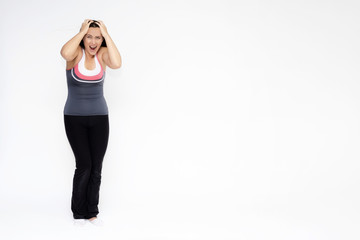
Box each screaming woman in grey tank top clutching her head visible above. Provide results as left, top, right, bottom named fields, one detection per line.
left=61, top=19, right=121, bottom=225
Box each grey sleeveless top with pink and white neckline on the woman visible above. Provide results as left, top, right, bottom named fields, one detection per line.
left=64, top=49, right=108, bottom=116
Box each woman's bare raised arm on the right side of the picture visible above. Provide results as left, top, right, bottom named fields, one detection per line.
left=98, top=21, right=122, bottom=69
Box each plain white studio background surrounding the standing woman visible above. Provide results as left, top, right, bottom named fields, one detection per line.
left=0, top=0, right=360, bottom=240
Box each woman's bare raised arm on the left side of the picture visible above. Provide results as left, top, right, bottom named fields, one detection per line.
left=60, top=19, right=92, bottom=62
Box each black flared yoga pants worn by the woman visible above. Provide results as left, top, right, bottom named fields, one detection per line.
left=64, top=115, right=109, bottom=219
